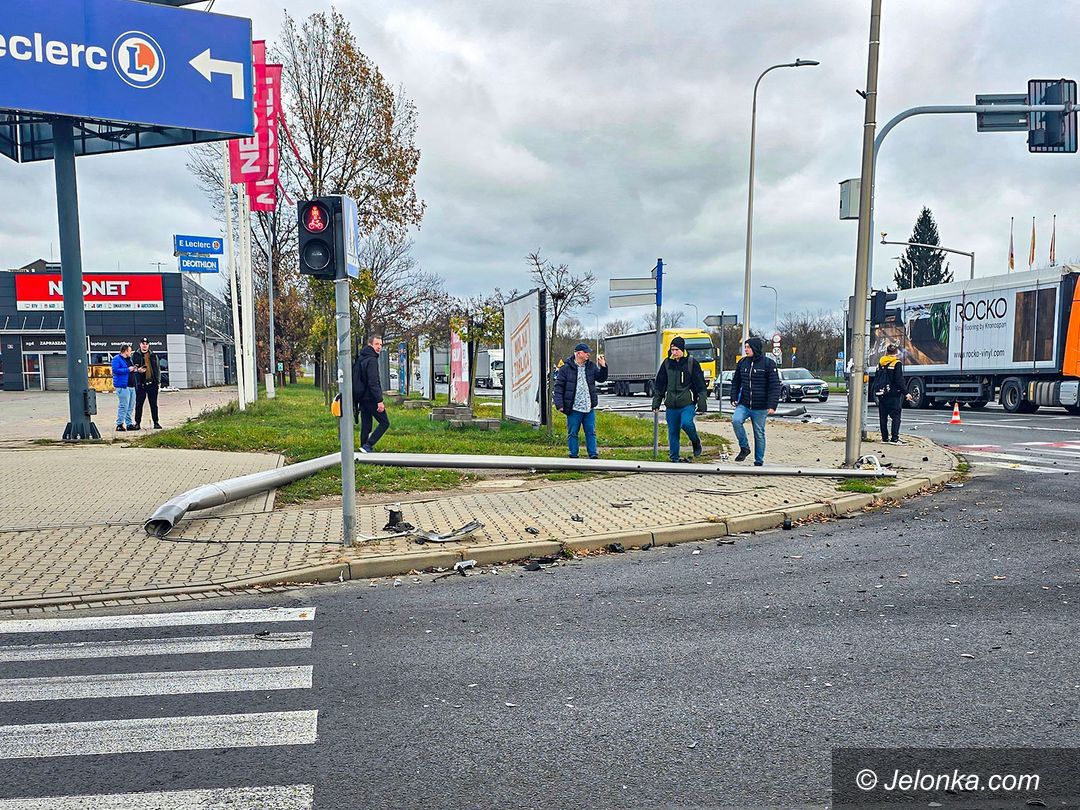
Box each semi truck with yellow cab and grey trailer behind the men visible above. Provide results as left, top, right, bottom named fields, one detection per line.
left=604, top=329, right=716, bottom=396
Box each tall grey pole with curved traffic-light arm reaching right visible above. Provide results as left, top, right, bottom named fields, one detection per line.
left=843, top=91, right=1080, bottom=467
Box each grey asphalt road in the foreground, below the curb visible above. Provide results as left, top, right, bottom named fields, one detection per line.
left=0, top=469, right=1080, bottom=810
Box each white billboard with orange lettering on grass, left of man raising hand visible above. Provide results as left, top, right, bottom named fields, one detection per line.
left=502, top=289, right=545, bottom=424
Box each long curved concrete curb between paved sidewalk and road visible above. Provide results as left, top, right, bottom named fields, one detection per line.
left=0, top=448, right=958, bottom=611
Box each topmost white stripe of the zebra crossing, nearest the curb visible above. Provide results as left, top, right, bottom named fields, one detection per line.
left=0, top=607, right=315, bottom=634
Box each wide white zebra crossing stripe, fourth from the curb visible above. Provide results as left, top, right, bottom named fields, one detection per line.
left=0, top=710, right=319, bottom=759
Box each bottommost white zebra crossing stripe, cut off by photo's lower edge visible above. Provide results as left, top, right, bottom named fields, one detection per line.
left=0, top=785, right=315, bottom=810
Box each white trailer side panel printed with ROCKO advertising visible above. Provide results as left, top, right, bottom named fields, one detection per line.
left=870, top=271, right=1061, bottom=374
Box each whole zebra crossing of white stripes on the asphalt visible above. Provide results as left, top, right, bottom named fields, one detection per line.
left=0, top=607, right=319, bottom=810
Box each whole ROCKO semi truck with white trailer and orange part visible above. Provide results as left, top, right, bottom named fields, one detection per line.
left=867, top=265, right=1080, bottom=415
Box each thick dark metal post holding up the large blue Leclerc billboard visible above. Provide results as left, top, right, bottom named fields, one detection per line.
left=53, top=119, right=102, bottom=442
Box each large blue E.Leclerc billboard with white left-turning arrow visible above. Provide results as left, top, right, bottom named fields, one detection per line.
left=0, top=0, right=254, bottom=135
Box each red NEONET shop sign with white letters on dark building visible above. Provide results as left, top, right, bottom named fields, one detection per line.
left=15, top=273, right=165, bottom=310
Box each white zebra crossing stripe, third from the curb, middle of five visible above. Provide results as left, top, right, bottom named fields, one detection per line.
left=0, top=666, right=312, bottom=703
